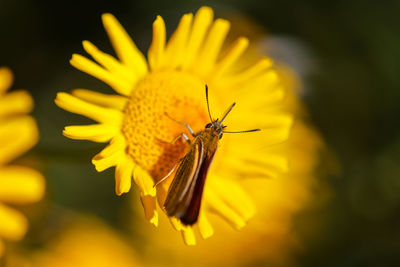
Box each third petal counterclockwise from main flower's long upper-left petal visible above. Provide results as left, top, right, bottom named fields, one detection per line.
left=70, top=54, right=134, bottom=96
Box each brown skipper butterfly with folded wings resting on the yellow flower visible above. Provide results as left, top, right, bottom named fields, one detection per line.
left=155, top=85, right=260, bottom=225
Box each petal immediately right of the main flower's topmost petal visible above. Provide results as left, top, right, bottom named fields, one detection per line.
left=194, top=19, right=230, bottom=75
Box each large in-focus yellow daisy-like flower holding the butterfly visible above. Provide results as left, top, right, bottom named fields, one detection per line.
left=55, top=7, right=292, bottom=244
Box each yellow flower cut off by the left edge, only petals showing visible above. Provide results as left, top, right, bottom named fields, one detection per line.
left=0, top=68, right=45, bottom=256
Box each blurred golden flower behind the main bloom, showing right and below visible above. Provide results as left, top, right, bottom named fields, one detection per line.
left=128, top=14, right=329, bottom=267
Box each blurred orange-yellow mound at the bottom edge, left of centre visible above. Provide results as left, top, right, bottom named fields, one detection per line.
left=28, top=217, right=144, bottom=267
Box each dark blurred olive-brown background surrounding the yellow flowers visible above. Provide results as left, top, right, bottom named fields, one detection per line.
left=0, top=0, right=400, bottom=266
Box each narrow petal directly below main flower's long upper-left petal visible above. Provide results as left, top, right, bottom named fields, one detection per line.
left=82, top=41, right=141, bottom=88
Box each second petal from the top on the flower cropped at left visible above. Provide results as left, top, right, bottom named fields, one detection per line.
left=0, top=90, right=33, bottom=117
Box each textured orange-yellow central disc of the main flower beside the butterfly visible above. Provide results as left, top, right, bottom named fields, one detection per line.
left=122, top=71, right=208, bottom=182
